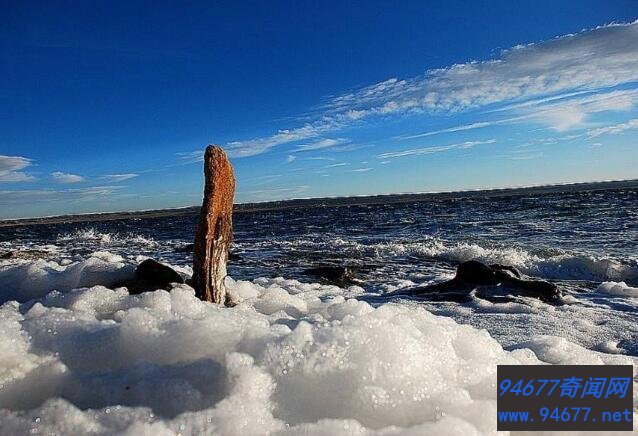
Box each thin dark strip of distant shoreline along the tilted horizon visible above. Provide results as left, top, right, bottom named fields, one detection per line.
left=0, top=179, right=638, bottom=227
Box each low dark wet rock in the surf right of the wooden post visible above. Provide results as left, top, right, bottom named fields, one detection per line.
left=409, top=260, right=561, bottom=302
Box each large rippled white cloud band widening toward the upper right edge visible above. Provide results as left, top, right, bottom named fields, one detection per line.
left=325, top=22, right=638, bottom=114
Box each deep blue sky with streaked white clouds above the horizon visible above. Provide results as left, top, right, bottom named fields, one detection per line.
left=0, top=0, right=638, bottom=218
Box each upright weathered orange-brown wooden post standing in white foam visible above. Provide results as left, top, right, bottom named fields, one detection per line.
left=193, top=145, right=235, bottom=305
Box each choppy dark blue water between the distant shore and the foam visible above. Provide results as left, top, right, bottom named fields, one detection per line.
left=0, top=189, right=638, bottom=290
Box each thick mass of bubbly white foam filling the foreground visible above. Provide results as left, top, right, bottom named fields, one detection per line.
left=0, top=259, right=638, bottom=435
